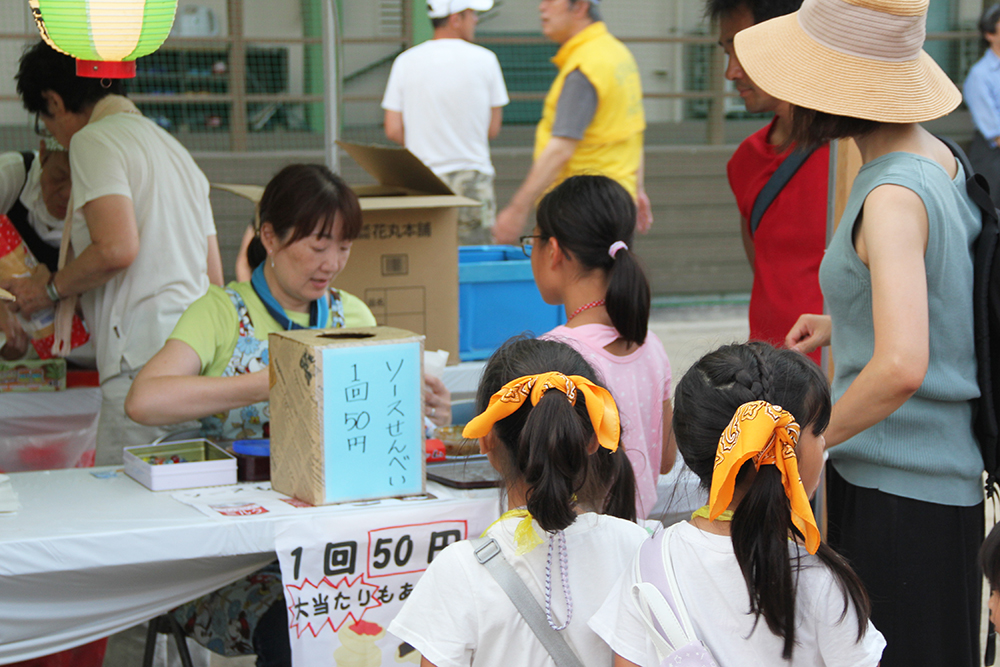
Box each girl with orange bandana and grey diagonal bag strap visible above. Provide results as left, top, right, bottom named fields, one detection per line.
left=389, top=339, right=648, bottom=667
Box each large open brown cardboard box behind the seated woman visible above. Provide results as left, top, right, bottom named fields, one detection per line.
left=213, top=142, right=479, bottom=363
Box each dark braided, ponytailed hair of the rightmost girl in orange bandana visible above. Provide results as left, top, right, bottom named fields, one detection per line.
left=673, top=342, right=871, bottom=660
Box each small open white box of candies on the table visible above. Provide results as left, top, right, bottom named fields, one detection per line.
left=122, top=439, right=236, bottom=491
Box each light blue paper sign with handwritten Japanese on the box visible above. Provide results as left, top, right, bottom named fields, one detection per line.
left=323, top=343, right=423, bottom=502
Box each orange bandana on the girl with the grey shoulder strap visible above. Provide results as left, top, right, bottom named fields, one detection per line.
left=462, top=371, right=621, bottom=452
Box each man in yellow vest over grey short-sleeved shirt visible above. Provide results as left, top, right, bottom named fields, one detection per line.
left=493, top=0, right=652, bottom=243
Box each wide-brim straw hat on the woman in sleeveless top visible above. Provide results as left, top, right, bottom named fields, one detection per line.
left=734, top=0, right=962, bottom=123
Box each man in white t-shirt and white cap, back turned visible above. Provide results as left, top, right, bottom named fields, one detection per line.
left=382, top=0, right=510, bottom=244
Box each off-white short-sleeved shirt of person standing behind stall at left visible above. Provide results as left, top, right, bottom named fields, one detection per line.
left=69, top=113, right=215, bottom=382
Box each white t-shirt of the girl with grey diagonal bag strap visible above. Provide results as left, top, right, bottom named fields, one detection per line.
left=389, top=513, right=649, bottom=667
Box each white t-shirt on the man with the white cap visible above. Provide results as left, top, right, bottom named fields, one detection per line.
left=382, top=39, right=510, bottom=176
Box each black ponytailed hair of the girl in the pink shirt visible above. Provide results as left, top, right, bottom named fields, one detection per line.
left=536, top=176, right=650, bottom=345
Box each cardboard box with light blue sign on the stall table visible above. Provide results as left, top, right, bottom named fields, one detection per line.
left=268, top=327, right=425, bottom=505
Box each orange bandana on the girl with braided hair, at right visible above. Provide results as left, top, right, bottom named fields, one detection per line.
left=708, top=401, right=820, bottom=554
